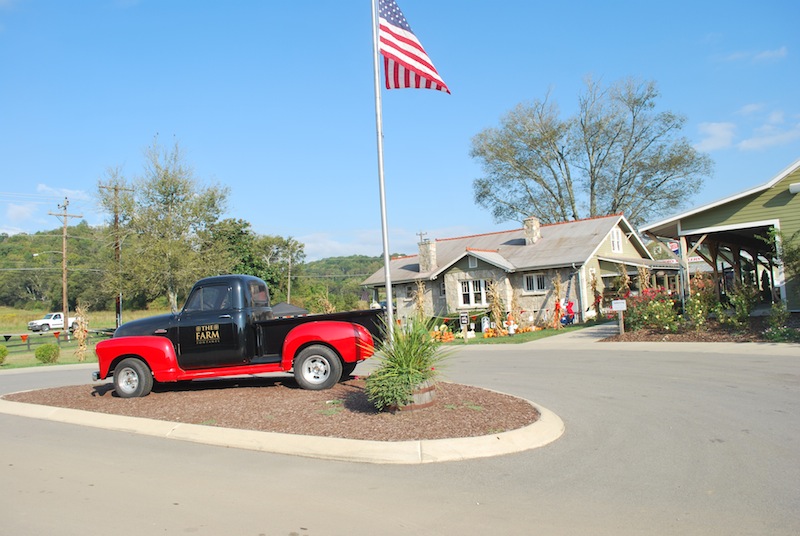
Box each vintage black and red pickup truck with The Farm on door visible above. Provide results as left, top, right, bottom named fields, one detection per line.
left=93, top=275, right=383, bottom=398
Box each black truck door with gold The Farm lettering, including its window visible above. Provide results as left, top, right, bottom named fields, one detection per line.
left=178, top=284, right=242, bottom=369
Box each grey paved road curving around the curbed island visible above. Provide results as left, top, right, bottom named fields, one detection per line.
left=0, top=332, right=800, bottom=536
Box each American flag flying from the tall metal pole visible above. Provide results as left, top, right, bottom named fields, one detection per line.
left=378, top=0, right=450, bottom=93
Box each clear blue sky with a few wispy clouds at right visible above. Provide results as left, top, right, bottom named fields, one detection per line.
left=0, top=0, right=800, bottom=260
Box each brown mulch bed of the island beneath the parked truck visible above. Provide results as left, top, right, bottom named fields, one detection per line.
left=3, top=377, right=539, bottom=441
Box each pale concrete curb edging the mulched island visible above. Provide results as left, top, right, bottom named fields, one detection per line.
left=0, top=400, right=565, bottom=464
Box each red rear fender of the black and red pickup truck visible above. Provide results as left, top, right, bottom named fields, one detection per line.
left=281, top=320, right=375, bottom=370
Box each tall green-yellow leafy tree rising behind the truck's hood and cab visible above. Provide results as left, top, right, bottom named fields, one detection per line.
left=101, top=140, right=230, bottom=311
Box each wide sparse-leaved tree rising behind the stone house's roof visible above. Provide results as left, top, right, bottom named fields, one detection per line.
left=470, top=78, right=712, bottom=223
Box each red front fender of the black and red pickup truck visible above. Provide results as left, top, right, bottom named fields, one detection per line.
left=95, top=335, right=179, bottom=382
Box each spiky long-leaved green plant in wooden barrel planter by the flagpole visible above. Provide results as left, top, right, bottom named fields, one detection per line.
left=365, top=320, right=446, bottom=411
